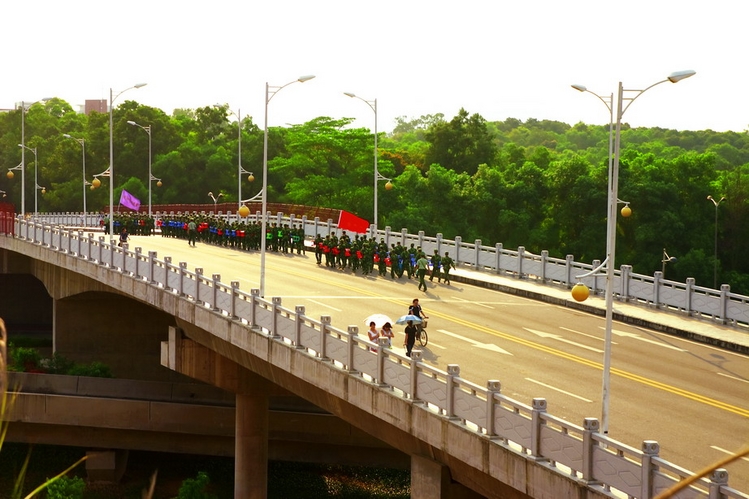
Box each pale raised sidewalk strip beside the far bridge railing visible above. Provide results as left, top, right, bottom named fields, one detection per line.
left=450, top=268, right=749, bottom=355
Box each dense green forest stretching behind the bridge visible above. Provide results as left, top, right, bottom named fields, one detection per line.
left=0, top=99, right=749, bottom=294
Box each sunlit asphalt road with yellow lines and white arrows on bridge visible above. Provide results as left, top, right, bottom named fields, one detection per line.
left=125, top=236, right=749, bottom=493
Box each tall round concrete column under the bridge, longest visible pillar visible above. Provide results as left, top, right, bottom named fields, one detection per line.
left=234, top=383, right=268, bottom=499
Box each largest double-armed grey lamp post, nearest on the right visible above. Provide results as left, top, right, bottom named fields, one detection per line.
left=572, top=70, right=696, bottom=433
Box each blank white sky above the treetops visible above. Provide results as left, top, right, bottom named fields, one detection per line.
left=0, top=0, right=749, bottom=132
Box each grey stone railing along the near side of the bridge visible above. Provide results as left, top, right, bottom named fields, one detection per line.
left=4, top=221, right=749, bottom=499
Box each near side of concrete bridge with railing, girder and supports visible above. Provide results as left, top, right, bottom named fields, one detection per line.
left=0, top=225, right=748, bottom=498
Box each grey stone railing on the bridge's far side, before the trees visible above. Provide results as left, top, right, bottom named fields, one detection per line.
left=29, top=212, right=749, bottom=328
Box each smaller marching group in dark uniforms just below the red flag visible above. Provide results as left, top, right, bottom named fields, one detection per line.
left=314, top=232, right=455, bottom=291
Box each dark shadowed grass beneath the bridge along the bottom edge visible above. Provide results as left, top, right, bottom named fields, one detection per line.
left=0, top=443, right=410, bottom=499
